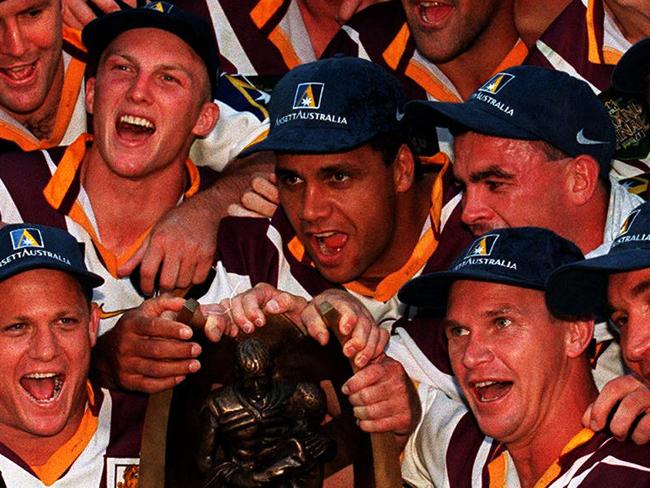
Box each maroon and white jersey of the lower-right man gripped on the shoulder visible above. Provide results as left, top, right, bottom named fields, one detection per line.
left=402, top=389, right=650, bottom=488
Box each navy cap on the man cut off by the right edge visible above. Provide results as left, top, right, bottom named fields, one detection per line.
left=547, top=202, right=650, bottom=319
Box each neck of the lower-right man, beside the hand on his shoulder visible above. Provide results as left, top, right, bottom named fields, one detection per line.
left=506, top=357, right=598, bottom=488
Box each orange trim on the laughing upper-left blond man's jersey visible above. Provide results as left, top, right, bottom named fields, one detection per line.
left=43, top=134, right=201, bottom=278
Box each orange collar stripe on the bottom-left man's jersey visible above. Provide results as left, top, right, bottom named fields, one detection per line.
left=30, top=382, right=99, bottom=486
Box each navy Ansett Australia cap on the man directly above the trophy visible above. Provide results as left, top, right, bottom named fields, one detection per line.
left=240, top=56, right=406, bottom=156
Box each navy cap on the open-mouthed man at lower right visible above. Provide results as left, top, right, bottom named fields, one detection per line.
left=398, top=227, right=583, bottom=310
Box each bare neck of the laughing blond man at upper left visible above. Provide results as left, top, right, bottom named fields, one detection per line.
left=81, top=144, right=186, bottom=256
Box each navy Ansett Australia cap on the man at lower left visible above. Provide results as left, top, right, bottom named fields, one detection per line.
left=0, top=224, right=104, bottom=289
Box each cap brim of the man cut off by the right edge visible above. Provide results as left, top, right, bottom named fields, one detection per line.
left=546, top=249, right=650, bottom=319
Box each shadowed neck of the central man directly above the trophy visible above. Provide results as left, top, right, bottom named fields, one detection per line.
left=357, top=175, right=435, bottom=288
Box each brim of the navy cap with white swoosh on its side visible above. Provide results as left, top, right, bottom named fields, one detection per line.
left=405, top=100, right=539, bottom=140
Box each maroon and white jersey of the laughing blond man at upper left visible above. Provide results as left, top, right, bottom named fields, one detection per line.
left=0, top=135, right=217, bottom=333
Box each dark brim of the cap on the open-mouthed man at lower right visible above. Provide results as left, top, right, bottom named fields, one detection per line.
left=398, top=270, right=544, bottom=312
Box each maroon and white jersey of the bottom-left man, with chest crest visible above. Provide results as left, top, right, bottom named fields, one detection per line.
left=0, top=386, right=147, bottom=488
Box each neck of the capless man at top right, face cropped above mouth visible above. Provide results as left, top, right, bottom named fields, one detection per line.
left=436, top=1, right=519, bottom=100
